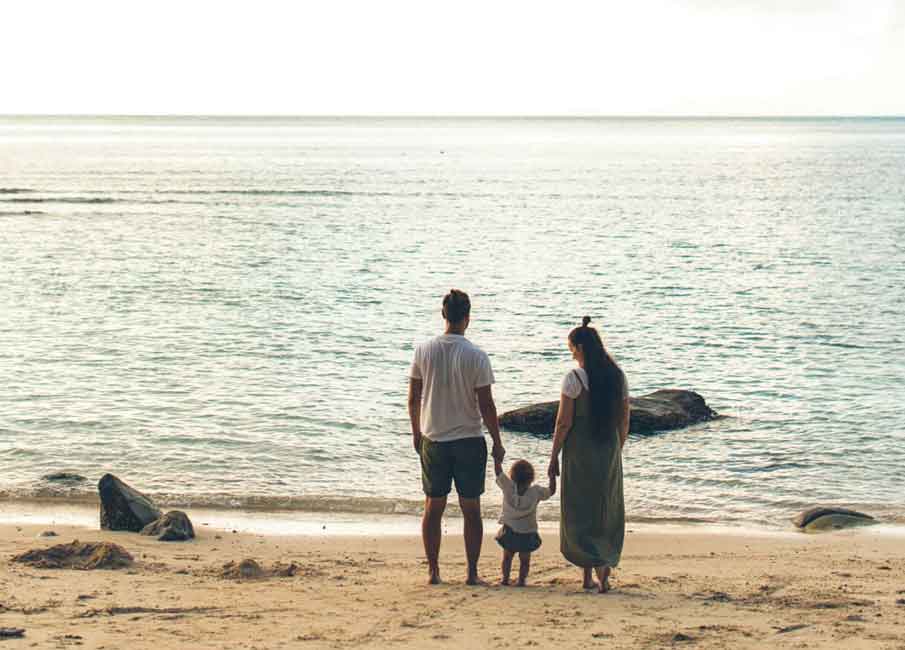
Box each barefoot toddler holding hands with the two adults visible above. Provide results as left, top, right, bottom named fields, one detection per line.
left=493, top=460, right=556, bottom=587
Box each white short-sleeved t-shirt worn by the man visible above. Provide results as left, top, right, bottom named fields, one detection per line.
left=409, top=334, right=493, bottom=442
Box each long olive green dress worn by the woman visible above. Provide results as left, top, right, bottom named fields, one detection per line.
left=559, top=370, right=625, bottom=568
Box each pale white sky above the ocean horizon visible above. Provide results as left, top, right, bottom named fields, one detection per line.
left=0, top=0, right=905, bottom=115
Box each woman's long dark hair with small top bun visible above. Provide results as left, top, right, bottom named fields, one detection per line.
left=569, top=316, right=625, bottom=437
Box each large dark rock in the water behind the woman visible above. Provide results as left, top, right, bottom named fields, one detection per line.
left=500, top=389, right=719, bottom=436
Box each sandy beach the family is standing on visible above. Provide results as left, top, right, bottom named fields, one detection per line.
left=0, top=513, right=905, bottom=648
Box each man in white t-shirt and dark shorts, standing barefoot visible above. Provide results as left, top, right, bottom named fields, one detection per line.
left=408, top=289, right=506, bottom=585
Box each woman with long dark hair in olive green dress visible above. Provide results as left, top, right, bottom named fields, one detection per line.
left=549, top=316, right=629, bottom=593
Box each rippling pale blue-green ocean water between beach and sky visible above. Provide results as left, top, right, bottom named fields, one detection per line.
left=0, top=117, right=905, bottom=524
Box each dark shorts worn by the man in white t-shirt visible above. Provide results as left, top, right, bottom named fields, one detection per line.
left=421, top=436, right=487, bottom=499
